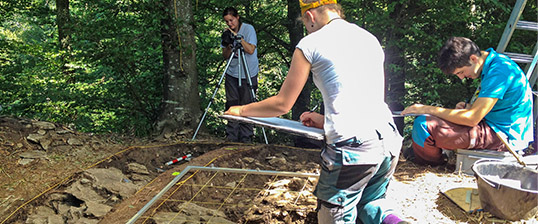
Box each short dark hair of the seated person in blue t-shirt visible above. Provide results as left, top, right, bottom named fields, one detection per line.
left=437, top=37, right=482, bottom=74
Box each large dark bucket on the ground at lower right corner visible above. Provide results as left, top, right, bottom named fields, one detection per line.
left=472, top=160, right=538, bottom=221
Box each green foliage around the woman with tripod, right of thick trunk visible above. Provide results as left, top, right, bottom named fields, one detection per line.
left=194, top=0, right=290, bottom=139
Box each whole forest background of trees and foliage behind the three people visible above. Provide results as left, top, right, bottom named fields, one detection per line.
left=0, top=0, right=537, bottom=142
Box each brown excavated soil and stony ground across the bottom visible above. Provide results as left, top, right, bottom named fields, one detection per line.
left=0, top=116, right=538, bottom=224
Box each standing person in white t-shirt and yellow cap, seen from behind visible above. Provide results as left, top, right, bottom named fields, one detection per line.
left=225, top=0, right=406, bottom=224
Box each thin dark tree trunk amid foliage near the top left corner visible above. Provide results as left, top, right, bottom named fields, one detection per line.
left=56, top=0, right=71, bottom=50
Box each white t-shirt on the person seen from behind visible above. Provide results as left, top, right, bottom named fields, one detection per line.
left=297, top=19, right=392, bottom=144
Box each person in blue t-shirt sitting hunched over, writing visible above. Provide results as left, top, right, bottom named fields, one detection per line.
left=402, top=37, right=533, bottom=165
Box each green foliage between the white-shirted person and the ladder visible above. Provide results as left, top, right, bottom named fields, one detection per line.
left=343, top=0, right=536, bottom=140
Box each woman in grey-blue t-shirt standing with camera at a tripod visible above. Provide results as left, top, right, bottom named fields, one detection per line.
left=221, top=7, right=259, bottom=143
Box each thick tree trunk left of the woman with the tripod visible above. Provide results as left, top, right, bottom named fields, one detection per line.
left=156, top=0, right=200, bottom=137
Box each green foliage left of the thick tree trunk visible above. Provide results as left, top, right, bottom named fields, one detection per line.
left=0, top=1, right=162, bottom=135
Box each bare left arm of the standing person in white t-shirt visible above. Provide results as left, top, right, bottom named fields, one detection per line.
left=224, top=49, right=311, bottom=117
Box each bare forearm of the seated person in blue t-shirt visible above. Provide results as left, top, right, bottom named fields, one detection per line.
left=402, top=97, right=497, bottom=127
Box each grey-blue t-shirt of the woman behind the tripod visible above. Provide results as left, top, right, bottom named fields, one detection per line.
left=221, top=23, right=259, bottom=79
